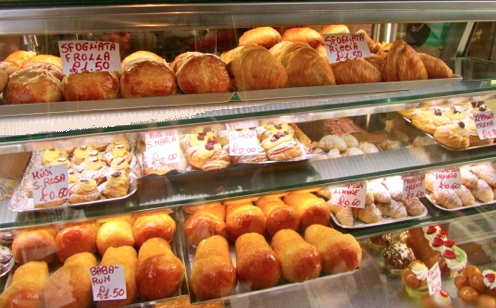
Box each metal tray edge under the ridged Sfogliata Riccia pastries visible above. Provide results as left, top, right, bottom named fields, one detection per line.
left=236, top=76, right=463, bottom=101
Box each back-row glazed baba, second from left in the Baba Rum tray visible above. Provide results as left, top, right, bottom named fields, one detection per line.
left=55, top=222, right=97, bottom=262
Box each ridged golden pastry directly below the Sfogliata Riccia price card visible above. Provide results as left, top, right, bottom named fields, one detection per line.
left=331, top=58, right=382, bottom=84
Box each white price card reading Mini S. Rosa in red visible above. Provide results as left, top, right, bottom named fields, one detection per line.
left=29, top=164, right=69, bottom=205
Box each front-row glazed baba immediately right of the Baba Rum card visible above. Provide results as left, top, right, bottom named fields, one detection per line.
left=136, top=237, right=184, bottom=300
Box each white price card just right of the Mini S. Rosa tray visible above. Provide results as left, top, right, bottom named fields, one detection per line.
left=145, top=130, right=181, bottom=168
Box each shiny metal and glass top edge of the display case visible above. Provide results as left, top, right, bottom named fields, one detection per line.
left=0, top=0, right=496, bottom=35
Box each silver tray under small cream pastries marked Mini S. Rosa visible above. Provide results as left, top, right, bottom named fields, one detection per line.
left=8, top=136, right=141, bottom=212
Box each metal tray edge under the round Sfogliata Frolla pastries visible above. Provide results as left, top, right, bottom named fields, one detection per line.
left=0, top=92, right=234, bottom=118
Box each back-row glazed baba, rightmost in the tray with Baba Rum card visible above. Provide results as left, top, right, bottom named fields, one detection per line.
left=132, top=212, right=176, bottom=247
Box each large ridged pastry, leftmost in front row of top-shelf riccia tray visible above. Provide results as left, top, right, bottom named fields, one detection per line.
left=224, top=45, right=289, bottom=91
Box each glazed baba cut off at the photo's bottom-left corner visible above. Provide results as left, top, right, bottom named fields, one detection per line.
left=0, top=261, right=48, bottom=307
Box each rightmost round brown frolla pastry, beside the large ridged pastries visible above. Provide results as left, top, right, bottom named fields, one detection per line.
left=176, top=54, right=232, bottom=94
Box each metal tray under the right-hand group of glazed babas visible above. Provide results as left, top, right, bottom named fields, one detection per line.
left=182, top=208, right=360, bottom=304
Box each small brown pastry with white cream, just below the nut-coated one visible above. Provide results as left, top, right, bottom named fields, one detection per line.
left=401, top=260, right=429, bottom=297
